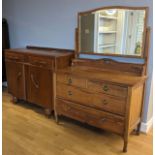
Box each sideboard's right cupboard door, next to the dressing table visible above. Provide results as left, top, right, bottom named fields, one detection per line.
left=28, top=66, right=53, bottom=109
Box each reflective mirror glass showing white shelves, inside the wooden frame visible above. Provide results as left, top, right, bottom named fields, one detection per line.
left=78, top=8, right=146, bottom=56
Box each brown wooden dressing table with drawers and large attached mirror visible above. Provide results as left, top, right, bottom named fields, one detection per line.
left=54, top=6, right=150, bottom=152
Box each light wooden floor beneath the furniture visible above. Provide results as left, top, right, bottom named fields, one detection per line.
left=3, top=92, right=152, bottom=155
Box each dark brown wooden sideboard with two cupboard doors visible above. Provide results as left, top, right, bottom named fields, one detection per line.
left=5, top=46, right=74, bottom=115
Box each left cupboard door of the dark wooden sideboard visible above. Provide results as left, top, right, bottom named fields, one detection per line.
left=6, top=61, right=26, bottom=99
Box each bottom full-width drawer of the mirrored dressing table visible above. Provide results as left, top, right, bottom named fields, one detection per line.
left=56, top=99, right=124, bottom=134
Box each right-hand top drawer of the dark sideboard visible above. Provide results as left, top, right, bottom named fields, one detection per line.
left=29, top=56, right=54, bottom=69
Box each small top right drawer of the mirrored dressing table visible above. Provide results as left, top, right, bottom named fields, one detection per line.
left=87, top=81, right=127, bottom=97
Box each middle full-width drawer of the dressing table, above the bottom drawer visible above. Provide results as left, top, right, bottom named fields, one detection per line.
left=57, top=83, right=126, bottom=115
